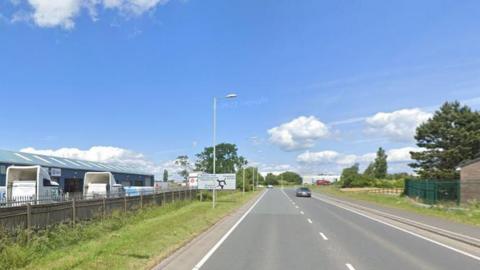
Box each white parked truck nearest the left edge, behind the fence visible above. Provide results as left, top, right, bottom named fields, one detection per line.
left=5, top=166, right=60, bottom=205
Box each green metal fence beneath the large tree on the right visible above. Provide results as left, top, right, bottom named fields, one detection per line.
left=404, top=179, right=460, bottom=204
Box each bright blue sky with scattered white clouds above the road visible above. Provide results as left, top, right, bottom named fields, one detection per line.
left=0, top=0, right=480, bottom=176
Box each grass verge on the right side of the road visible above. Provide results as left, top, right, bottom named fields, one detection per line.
left=313, top=186, right=480, bottom=226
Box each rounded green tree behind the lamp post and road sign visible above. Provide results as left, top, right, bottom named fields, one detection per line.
left=195, top=143, right=248, bottom=173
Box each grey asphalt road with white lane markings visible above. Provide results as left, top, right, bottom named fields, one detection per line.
left=201, top=189, right=480, bottom=270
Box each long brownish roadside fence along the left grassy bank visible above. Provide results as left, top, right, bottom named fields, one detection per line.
left=0, top=189, right=197, bottom=231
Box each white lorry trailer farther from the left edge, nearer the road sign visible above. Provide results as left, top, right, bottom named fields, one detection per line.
left=83, top=172, right=124, bottom=198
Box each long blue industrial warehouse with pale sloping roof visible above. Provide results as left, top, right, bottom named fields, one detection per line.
left=0, top=150, right=154, bottom=194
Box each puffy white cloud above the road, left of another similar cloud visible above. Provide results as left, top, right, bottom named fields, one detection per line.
left=268, top=116, right=330, bottom=151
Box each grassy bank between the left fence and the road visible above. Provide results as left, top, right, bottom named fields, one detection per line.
left=0, top=192, right=254, bottom=269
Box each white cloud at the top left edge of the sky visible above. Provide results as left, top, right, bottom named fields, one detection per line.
left=12, top=0, right=168, bottom=30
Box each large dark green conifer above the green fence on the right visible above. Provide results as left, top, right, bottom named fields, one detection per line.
left=410, top=101, right=480, bottom=180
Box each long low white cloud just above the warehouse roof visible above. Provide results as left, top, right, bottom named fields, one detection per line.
left=20, top=146, right=188, bottom=179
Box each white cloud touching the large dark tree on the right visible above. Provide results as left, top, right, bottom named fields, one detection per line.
left=365, top=108, right=432, bottom=141
